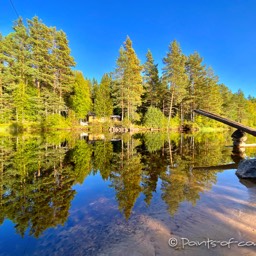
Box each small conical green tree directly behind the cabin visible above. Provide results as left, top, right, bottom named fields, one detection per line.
left=94, top=74, right=113, bottom=117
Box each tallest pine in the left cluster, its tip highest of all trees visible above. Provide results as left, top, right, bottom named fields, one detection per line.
left=27, top=17, right=57, bottom=120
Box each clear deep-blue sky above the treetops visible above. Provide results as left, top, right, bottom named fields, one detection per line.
left=0, top=0, right=256, bottom=96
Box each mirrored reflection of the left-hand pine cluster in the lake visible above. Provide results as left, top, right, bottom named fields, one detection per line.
left=0, top=136, right=75, bottom=237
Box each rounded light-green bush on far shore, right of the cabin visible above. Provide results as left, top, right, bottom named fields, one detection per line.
left=144, top=107, right=167, bottom=128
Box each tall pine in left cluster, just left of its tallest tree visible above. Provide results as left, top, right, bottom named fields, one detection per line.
left=4, top=18, right=33, bottom=122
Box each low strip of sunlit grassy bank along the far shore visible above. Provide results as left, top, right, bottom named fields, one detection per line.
left=0, top=115, right=229, bottom=134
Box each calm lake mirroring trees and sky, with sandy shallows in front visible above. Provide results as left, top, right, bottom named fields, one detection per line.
left=0, top=132, right=256, bottom=256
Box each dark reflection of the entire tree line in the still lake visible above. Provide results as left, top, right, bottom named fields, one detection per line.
left=0, top=133, right=255, bottom=240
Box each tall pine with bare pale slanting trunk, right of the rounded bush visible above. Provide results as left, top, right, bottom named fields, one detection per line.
left=163, top=41, right=188, bottom=125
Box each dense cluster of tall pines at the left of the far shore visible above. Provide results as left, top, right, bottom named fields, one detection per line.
left=0, top=17, right=75, bottom=126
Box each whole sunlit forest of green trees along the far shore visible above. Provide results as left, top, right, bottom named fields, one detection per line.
left=0, top=17, right=256, bottom=129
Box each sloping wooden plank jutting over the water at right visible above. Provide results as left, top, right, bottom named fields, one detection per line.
left=194, top=109, right=256, bottom=136
